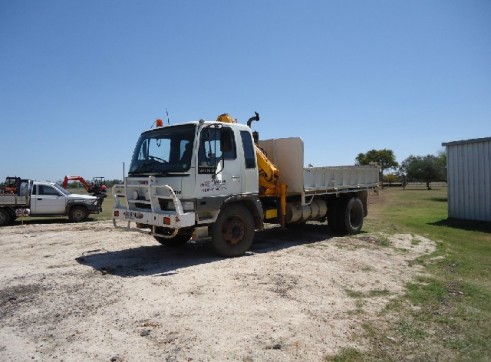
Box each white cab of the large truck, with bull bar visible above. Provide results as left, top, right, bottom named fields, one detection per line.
left=113, top=121, right=262, bottom=252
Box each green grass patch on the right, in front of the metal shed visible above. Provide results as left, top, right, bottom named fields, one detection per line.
left=338, top=187, right=491, bottom=361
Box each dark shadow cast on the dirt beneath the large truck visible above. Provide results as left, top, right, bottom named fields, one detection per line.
left=75, top=225, right=334, bottom=277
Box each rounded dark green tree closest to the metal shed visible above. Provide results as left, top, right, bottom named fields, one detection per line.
left=400, top=154, right=446, bottom=190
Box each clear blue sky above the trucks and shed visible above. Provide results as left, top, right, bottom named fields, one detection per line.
left=0, top=0, right=491, bottom=181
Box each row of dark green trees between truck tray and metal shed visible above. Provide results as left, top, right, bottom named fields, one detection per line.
left=355, top=149, right=447, bottom=190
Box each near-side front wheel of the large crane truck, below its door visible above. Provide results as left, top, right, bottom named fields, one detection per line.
left=209, top=204, right=254, bottom=257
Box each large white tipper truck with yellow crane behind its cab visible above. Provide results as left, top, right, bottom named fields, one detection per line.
left=112, top=113, right=379, bottom=257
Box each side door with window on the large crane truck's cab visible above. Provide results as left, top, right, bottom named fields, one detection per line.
left=196, top=126, right=242, bottom=198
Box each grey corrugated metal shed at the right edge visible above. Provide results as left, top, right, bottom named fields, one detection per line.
left=442, top=137, right=491, bottom=221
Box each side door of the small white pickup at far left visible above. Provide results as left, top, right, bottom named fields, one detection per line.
left=31, top=185, right=66, bottom=215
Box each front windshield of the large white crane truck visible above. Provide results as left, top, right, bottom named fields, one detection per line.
left=128, top=125, right=196, bottom=175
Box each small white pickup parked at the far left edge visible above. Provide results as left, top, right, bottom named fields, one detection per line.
left=0, top=178, right=102, bottom=226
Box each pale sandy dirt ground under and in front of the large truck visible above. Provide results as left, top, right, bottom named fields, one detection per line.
left=0, top=222, right=435, bottom=361
